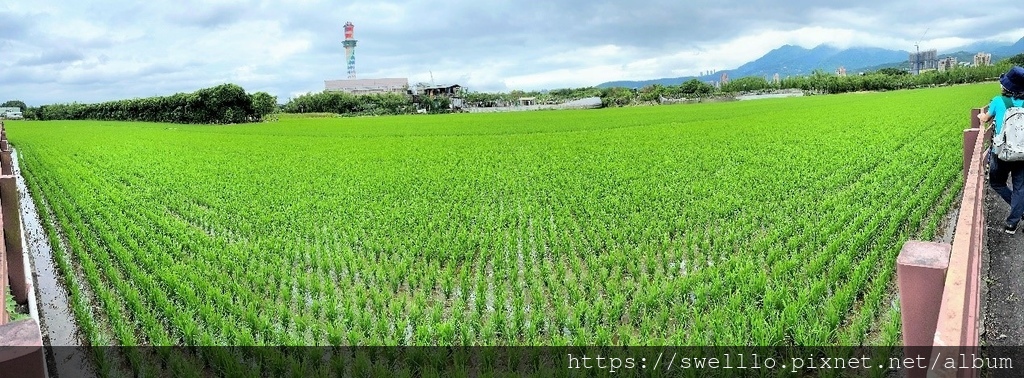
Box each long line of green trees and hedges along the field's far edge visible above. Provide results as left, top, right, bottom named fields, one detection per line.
left=5, top=53, right=1024, bottom=120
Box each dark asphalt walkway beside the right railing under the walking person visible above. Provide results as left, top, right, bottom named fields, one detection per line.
left=981, top=184, right=1024, bottom=346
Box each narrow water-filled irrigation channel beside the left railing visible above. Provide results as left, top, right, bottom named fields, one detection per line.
left=11, top=149, right=94, bottom=377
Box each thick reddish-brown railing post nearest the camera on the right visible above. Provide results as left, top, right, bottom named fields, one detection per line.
left=896, top=241, right=952, bottom=377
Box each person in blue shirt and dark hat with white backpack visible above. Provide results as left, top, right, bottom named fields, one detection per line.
left=978, top=66, right=1024, bottom=235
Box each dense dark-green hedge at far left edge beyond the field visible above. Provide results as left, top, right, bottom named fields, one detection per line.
left=35, top=84, right=278, bottom=124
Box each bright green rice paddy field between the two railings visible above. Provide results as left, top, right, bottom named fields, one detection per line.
left=0, top=84, right=997, bottom=369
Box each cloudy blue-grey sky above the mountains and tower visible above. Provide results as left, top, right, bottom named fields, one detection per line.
left=0, top=0, right=1024, bottom=106
